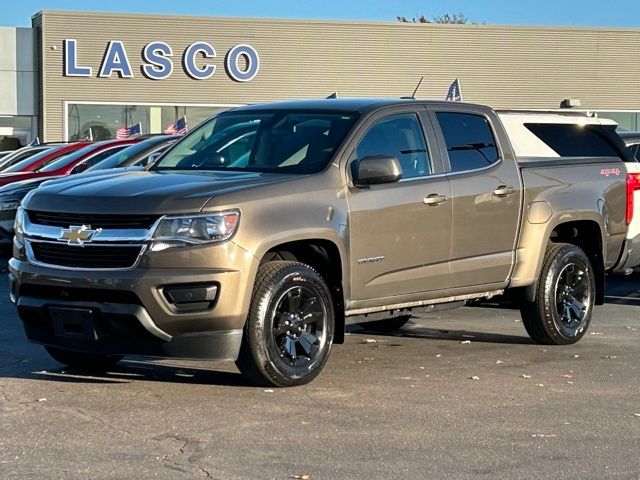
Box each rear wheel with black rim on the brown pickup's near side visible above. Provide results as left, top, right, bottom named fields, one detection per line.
left=520, top=243, right=596, bottom=345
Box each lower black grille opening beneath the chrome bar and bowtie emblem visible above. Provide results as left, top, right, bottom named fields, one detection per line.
left=30, top=242, right=143, bottom=269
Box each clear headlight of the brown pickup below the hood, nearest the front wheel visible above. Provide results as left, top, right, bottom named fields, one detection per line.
left=151, top=210, right=240, bottom=252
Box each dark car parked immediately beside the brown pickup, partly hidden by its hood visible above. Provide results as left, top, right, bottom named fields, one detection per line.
left=0, top=135, right=181, bottom=247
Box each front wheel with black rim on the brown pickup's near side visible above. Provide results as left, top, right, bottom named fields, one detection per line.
left=236, top=261, right=335, bottom=387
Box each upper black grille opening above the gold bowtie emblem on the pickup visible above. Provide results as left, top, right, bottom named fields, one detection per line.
left=27, top=210, right=158, bottom=230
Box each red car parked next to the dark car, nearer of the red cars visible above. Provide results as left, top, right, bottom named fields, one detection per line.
left=0, top=137, right=144, bottom=186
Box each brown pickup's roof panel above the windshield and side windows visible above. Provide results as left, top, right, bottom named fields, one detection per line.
left=228, top=98, right=487, bottom=113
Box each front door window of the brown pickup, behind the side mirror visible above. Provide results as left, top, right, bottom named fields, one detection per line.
left=356, top=113, right=431, bottom=178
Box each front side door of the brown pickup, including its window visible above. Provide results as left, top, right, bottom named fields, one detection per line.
left=347, top=106, right=451, bottom=303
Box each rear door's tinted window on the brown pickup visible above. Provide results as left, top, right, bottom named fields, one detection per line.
left=436, top=112, right=500, bottom=172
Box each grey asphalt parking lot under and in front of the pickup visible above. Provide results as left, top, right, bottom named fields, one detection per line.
left=0, top=262, right=640, bottom=480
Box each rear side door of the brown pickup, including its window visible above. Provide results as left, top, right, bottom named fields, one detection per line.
left=431, top=107, right=522, bottom=290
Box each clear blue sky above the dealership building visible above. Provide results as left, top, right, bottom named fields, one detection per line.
left=0, top=0, right=640, bottom=28
